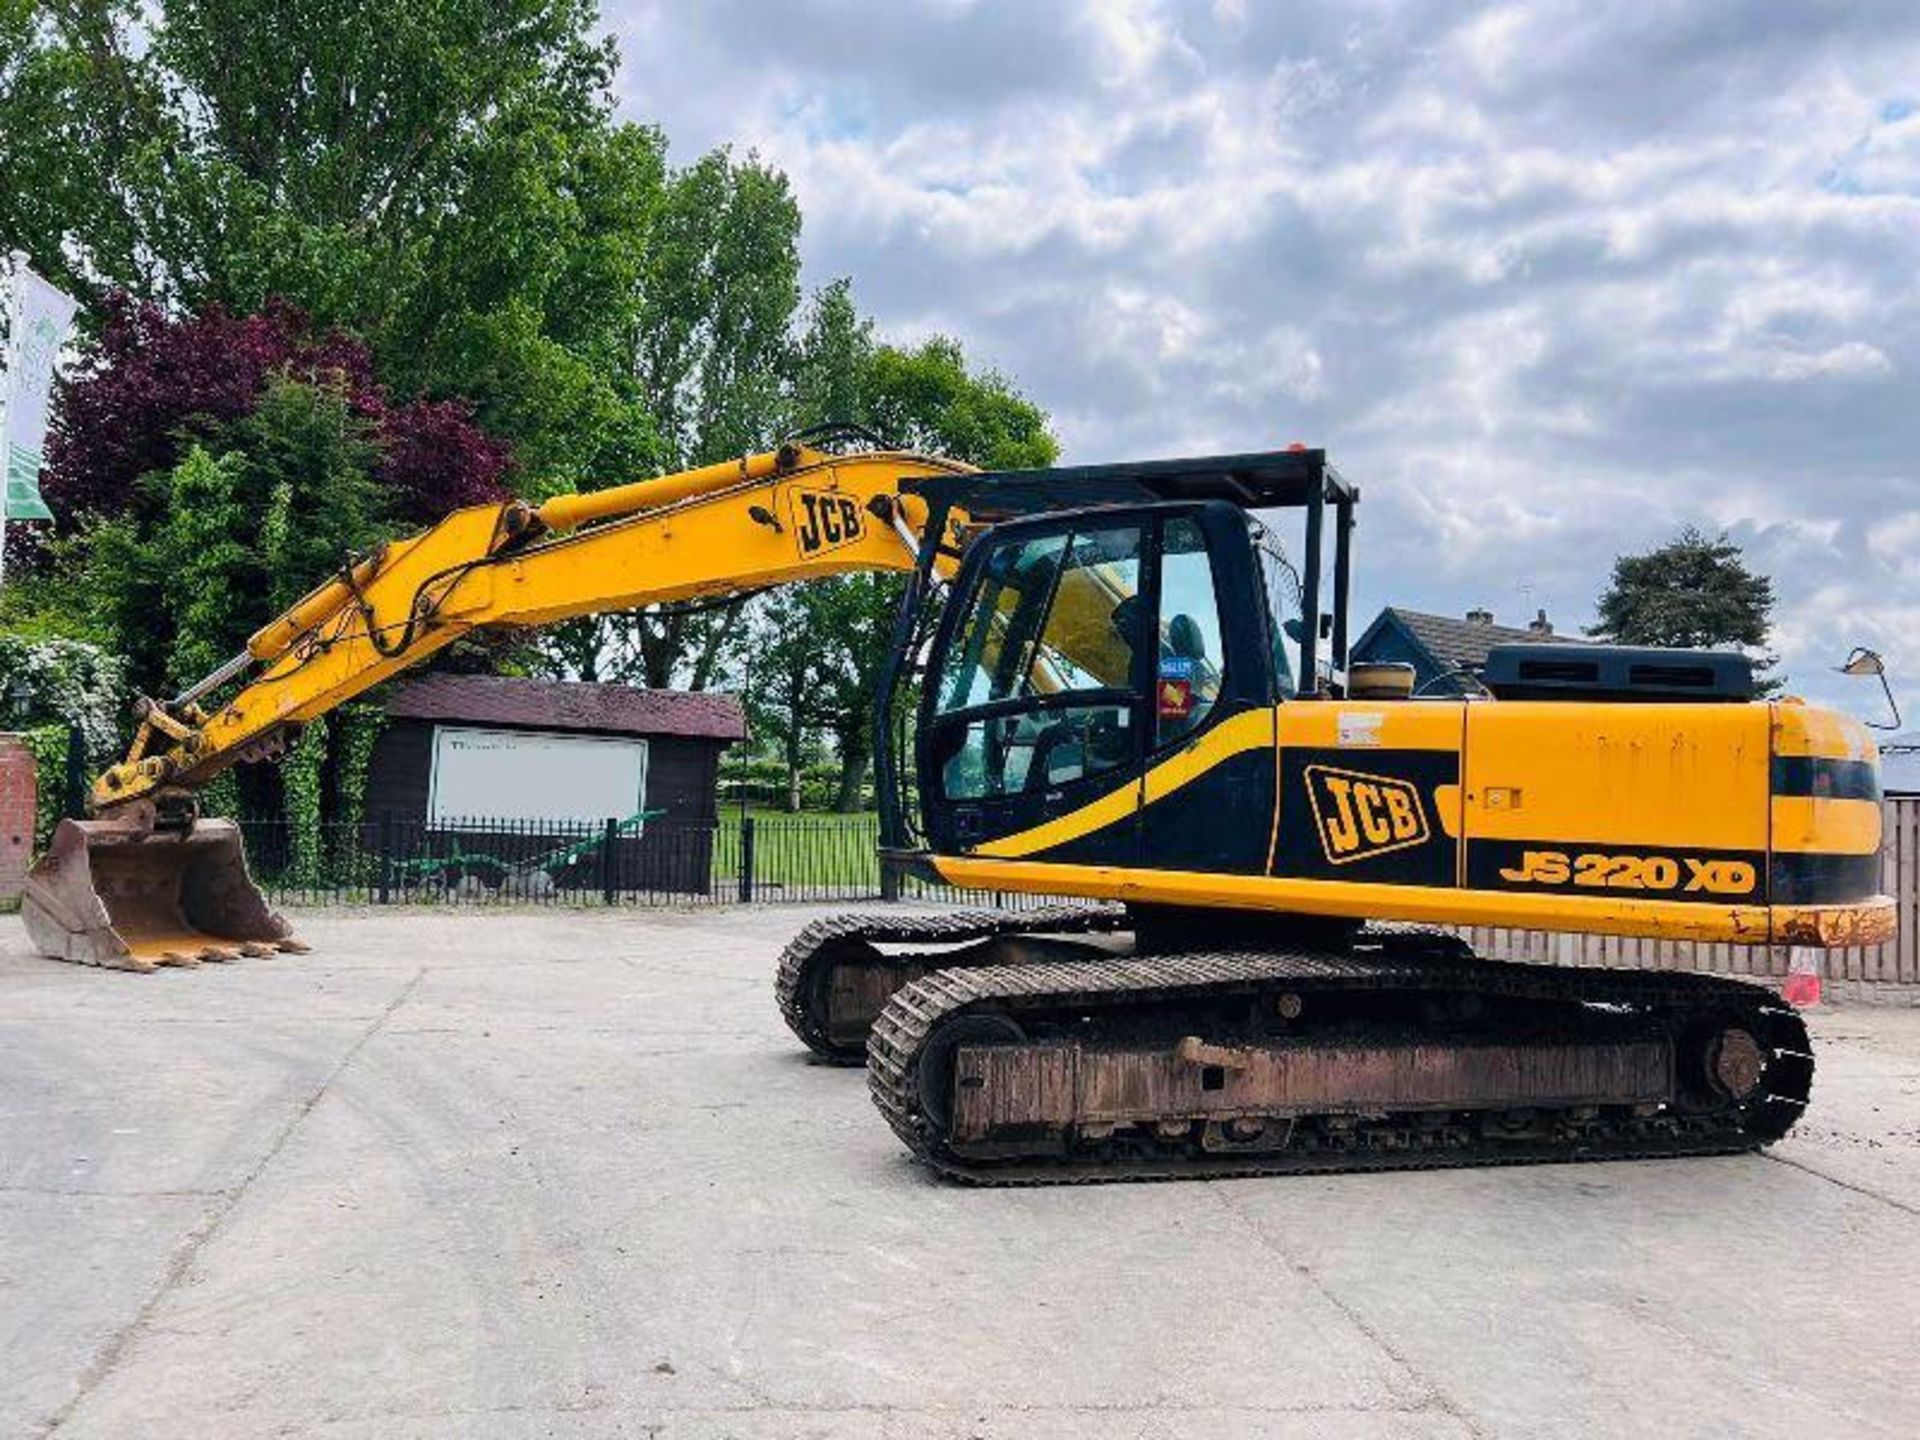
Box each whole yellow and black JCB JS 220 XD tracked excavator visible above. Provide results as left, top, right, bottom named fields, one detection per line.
left=25, top=436, right=1893, bottom=1183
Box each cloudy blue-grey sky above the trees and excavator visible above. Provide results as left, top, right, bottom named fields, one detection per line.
left=605, top=0, right=1920, bottom=724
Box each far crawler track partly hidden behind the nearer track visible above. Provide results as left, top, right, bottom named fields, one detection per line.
left=774, top=904, right=1127, bottom=1066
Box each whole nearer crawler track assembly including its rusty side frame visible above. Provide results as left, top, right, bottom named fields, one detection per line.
left=868, top=935, right=1812, bottom=1185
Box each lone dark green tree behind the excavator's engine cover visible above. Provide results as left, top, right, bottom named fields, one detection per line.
left=1592, top=526, right=1782, bottom=691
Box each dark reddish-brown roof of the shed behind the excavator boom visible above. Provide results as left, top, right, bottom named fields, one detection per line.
left=386, top=674, right=747, bottom=741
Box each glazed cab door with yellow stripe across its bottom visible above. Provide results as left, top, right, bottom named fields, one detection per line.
left=918, top=513, right=1150, bottom=866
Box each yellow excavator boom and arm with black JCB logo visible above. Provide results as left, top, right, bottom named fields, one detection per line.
left=92, top=445, right=972, bottom=816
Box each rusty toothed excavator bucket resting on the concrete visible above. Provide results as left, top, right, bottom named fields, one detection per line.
left=21, top=818, right=307, bottom=972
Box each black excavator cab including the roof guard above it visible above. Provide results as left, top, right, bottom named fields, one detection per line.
left=879, top=451, right=1356, bottom=874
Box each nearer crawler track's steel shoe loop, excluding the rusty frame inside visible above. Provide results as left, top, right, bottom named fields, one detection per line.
left=868, top=935, right=1812, bottom=1185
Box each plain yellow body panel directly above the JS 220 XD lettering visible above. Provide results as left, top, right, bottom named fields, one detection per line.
left=1467, top=701, right=1770, bottom=851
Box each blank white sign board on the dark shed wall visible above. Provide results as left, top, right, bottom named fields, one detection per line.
left=426, top=726, right=647, bottom=829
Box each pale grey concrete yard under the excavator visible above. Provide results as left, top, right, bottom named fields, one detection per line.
left=0, top=908, right=1920, bottom=1440
